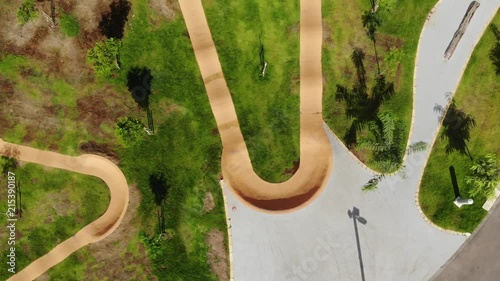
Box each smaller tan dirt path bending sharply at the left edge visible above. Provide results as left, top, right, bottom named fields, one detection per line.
left=0, top=139, right=129, bottom=281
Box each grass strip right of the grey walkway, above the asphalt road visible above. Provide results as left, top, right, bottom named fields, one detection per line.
left=419, top=13, right=500, bottom=232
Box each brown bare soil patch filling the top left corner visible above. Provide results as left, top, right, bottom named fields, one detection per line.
left=0, top=0, right=111, bottom=77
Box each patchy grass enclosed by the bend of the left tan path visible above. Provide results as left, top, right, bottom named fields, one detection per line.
left=0, top=160, right=109, bottom=280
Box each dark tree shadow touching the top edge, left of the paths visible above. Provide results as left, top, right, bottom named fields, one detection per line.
left=99, top=0, right=130, bottom=39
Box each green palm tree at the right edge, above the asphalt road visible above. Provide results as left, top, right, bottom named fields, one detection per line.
left=465, top=154, right=500, bottom=197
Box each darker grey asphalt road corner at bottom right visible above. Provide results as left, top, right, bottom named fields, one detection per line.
left=431, top=200, right=500, bottom=281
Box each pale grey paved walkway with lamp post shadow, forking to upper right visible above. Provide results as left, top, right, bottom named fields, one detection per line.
left=224, top=0, right=500, bottom=281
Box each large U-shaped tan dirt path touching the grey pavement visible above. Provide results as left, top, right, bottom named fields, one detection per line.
left=179, top=0, right=333, bottom=211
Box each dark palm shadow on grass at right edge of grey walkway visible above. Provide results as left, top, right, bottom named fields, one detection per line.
left=434, top=99, right=476, bottom=160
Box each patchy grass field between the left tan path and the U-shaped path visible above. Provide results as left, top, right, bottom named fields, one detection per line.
left=0, top=0, right=228, bottom=280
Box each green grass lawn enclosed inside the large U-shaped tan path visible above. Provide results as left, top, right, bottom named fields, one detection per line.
left=203, top=0, right=300, bottom=182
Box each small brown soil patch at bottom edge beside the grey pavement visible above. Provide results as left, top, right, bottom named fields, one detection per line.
left=206, top=229, right=229, bottom=281
